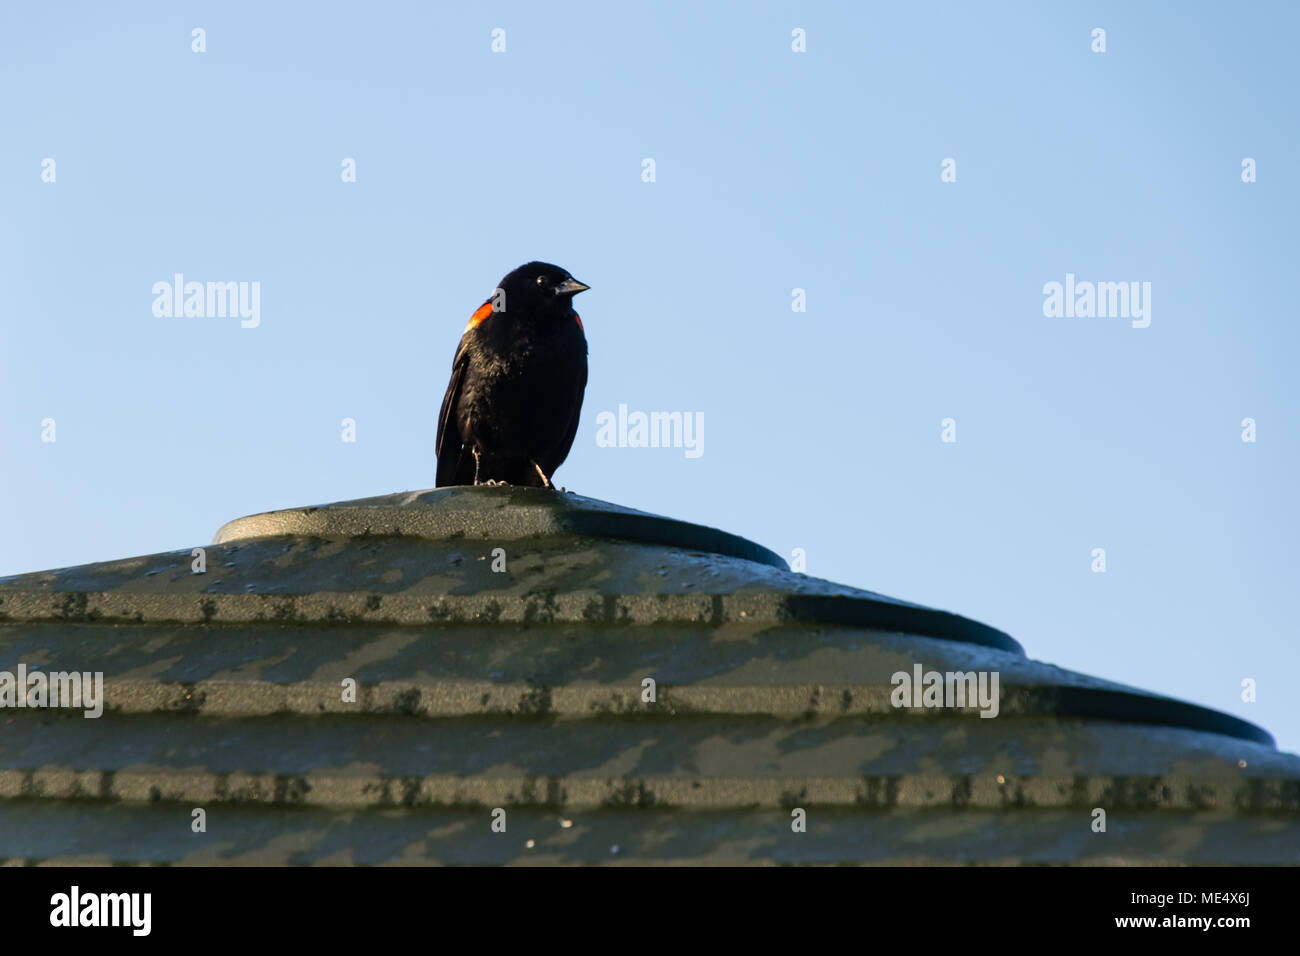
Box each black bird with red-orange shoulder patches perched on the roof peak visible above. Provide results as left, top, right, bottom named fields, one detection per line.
left=437, top=263, right=590, bottom=488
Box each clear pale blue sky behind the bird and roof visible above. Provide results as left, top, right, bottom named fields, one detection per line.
left=0, top=3, right=1300, bottom=750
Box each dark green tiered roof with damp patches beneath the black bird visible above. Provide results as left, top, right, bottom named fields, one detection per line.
left=0, top=488, right=1300, bottom=864
